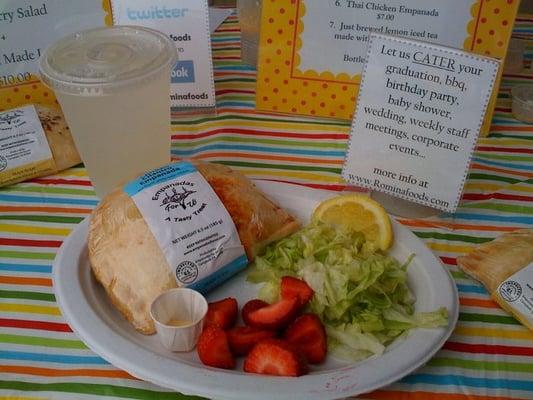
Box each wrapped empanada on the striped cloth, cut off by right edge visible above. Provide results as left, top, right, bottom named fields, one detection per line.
left=457, top=229, right=533, bottom=330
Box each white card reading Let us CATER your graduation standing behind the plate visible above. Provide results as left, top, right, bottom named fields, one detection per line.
left=342, top=34, right=499, bottom=212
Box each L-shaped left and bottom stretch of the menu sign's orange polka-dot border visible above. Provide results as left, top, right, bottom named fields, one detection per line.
left=256, top=0, right=359, bottom=119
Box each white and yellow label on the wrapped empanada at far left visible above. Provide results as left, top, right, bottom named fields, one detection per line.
left=0, top=105, right=55, bottom=186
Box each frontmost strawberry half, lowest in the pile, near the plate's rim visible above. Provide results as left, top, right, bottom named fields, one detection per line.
left=244, top=339, right=307, bottom=376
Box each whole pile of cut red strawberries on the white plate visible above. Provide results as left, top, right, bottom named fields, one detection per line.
left=197, top=276, right=327, bottom=377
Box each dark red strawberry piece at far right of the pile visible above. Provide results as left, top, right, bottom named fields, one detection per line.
left=283, top=313, right=328, bottom=364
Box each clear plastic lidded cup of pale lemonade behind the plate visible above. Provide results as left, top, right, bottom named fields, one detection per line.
left=39, top=26, right=177, bottom=197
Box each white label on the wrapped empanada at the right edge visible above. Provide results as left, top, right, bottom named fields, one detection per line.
left=497, top=263, right=533, bottom=327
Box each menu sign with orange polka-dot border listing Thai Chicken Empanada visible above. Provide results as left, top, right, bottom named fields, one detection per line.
left=256, top=0, right=519, bottom=136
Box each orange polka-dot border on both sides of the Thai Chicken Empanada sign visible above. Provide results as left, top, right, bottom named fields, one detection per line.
left=256, top=0, right=518, bottom=128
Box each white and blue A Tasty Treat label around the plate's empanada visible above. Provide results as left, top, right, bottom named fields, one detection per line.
left=124, top=162, right=248, bottom=292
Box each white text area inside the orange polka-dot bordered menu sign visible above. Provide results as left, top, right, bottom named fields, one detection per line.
left=298, top=0, right=475, bottom=75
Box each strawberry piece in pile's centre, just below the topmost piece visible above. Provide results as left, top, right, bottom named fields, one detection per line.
left=248, top=297, right=300, bottom=329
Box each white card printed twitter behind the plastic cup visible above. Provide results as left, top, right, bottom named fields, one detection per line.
left=111, top=0, right=215, bottom=107
